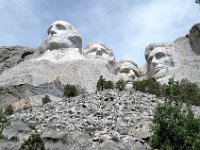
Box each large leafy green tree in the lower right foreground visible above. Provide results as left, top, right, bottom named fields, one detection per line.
left=151, top=79, right=200, bottom=150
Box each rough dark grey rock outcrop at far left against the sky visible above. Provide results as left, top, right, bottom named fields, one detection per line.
left=0, top=46, right=34, bottom=73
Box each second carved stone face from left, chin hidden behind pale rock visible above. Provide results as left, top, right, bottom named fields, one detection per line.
left=83, top=43, right=115, bottom=61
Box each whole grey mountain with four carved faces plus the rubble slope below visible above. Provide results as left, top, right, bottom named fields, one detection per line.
left=0, top=21, right=200, bottom=150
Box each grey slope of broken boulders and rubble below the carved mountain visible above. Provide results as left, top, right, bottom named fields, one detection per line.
left=0, top=90, right=200, bottom=150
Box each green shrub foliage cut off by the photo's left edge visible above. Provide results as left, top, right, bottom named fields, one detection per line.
left=0, top=108, right=10, bottom=139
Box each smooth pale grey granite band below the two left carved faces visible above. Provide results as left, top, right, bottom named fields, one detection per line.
left=0, top=60, right=115, bottom=93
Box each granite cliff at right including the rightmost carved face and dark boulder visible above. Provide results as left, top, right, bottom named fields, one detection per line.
left=142, top=27, right=200, bottom=86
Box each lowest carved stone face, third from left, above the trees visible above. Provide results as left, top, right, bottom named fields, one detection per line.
left=117, top=61, right=139, bottom=88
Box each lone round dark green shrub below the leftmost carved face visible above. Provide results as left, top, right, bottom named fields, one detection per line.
left=63, top=84, right=78, bottom=97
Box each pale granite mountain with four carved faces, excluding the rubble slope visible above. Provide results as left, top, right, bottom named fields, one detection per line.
left=0, top=21, right=200, bottom=107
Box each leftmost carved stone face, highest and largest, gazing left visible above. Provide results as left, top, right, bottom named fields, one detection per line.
left=47, top=21, right=82, bottom=50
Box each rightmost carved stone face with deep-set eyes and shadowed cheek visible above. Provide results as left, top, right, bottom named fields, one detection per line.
left=147, top=47, right=173, bottom=79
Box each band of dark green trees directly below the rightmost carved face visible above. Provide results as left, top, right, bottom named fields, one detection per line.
left=133, top=78, right=200, bottom=106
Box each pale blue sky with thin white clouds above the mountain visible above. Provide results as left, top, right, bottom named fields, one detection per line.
left=0, top=0, right=200, bottom=65
